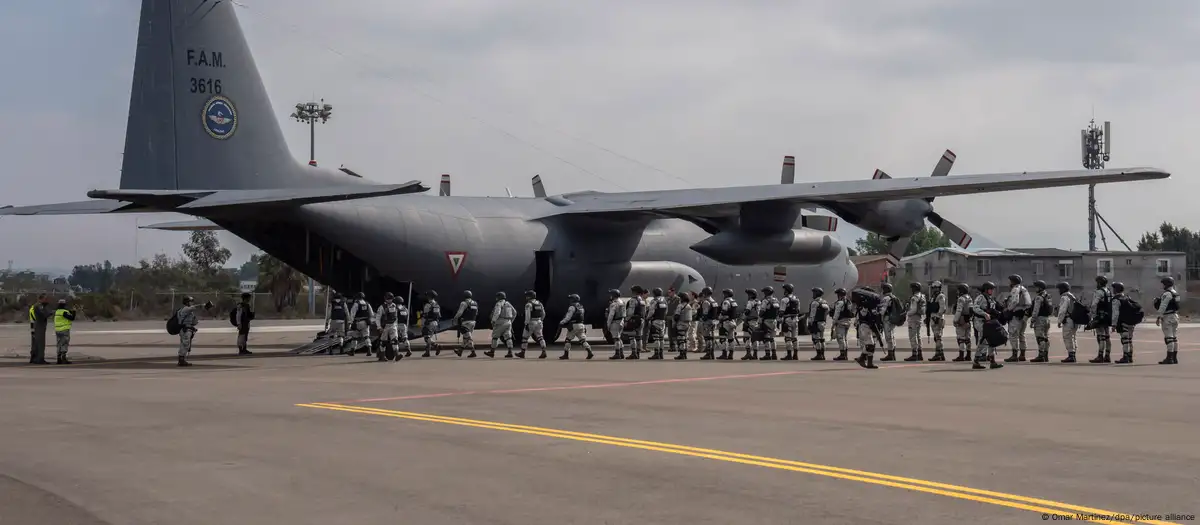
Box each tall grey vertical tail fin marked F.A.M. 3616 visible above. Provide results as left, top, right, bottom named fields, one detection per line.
left=120, top=0, right=350, bottom=189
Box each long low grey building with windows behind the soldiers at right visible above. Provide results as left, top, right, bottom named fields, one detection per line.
left=894, top=248, right=1187, bottom=309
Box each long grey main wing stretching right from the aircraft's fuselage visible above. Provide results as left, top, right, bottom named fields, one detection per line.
left=536, top=168, right=1170, bottom=221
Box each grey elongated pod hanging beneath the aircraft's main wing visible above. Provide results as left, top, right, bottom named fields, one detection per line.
left=691, top=230, right=842, bottom=266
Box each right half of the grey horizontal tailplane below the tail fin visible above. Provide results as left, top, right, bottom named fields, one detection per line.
left=179, top=181, right=430, bottom=210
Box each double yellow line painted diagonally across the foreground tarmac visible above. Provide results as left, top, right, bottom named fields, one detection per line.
left=296, top=403, right=1177, bottom=525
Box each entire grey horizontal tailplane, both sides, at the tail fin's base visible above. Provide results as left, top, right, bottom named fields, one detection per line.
left=0, top=181, right=430, bottom=216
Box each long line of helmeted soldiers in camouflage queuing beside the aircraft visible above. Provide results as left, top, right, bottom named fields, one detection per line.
left=312, top=274, right=1180, bottom=369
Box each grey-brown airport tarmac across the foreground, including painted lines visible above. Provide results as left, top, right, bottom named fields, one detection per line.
left=0, top=324, right=1200, bottom=525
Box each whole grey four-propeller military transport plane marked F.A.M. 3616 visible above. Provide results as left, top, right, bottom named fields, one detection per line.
left=0, top=0, right=1170, bottom=345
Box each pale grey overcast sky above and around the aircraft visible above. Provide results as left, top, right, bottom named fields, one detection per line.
left=0, top=0, right=1200, bottom=274
